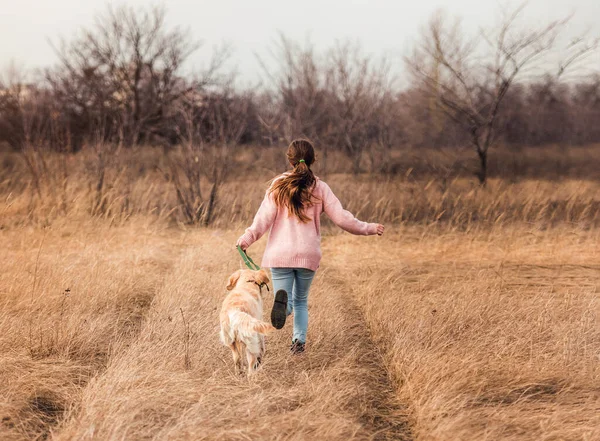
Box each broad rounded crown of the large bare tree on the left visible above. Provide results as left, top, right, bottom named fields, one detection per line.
left=47, top=6, right=202, bottom=145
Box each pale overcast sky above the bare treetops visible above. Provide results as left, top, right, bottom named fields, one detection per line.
left=0, top=0, right=600, bottom=80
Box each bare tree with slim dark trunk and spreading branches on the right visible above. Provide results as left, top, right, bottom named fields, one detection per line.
left=405, top=6, right=595, bottom=184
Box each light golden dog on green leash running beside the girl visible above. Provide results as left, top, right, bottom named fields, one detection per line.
left=219, top=269, right=275, bottom=376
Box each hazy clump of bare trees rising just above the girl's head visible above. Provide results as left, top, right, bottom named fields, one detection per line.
left=259, top=35, right=396, bottom=173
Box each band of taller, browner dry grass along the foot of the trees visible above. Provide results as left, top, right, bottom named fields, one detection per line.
left=0, top=147, right=600, bottom=229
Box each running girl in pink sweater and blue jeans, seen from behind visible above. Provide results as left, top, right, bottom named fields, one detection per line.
left=237, top=139, right=384, bottom=354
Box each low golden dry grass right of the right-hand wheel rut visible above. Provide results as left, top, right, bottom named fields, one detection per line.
left=325, top=226, right=600, bottom=440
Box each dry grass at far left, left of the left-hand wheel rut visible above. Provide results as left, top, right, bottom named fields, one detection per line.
left=0, top=230, right=186, bottom=440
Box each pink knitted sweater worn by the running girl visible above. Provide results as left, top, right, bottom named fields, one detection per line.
left=237, top=175, right=377, bottom=271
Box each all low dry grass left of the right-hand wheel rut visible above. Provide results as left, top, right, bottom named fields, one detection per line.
left=0, top=224, right=408, bottom=440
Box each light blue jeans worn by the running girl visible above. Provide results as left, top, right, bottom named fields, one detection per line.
left=271, top=268, right=315, bottom=343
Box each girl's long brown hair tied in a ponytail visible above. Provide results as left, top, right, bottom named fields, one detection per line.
left=270, top=139, right=317, bottom=222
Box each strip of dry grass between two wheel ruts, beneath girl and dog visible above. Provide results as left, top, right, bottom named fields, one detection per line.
left=49, top=233, right=411, bottom=440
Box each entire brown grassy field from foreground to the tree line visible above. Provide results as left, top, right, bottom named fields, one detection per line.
left=0, top=146, right=600, bottom=441
